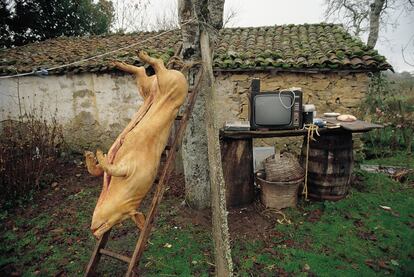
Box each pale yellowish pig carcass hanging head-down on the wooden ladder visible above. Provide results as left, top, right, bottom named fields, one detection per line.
left=85, top=51, right=188, bottom=238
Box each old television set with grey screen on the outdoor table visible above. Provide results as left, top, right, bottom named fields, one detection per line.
left=250, top=79, right=303, bottom=130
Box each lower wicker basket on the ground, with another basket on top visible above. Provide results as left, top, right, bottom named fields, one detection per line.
left=255, top=171, right=303, bottom=210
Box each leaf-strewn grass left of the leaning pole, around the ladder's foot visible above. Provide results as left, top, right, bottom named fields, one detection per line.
left=0, top=182, right=214, bottom=276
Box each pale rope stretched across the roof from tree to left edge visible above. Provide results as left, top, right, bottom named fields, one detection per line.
left=0, top=18, right=198, bottom=79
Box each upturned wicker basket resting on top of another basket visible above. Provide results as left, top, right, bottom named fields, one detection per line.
left=264, top=152, right=305, bottom=182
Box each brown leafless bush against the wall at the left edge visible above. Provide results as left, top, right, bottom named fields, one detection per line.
left=0, top=110, right=63, bottom=203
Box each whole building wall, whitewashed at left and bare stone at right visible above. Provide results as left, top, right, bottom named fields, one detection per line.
left=0, top=72, right=369, bottom=151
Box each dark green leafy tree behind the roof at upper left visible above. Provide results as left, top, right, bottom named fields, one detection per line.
left=0, top=0, right=114, bottom=47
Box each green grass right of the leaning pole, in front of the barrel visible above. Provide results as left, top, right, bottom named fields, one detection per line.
left=233, top=171, right=414, bottom=276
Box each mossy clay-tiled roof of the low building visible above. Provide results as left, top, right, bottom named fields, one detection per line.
left=0, top=23, right=391, bottom=75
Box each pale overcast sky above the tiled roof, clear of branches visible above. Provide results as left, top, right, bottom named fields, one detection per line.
left=148, top=0, right=414, bottom=71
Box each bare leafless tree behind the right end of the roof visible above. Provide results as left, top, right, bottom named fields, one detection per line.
left=325, top=0, right=414, bottom=48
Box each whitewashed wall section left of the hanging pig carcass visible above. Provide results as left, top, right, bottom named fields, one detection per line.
left=0, top=73, right=142, bottom=151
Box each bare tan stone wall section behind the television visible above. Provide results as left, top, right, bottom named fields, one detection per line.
left=216, top=72, right=369, bottom=152
